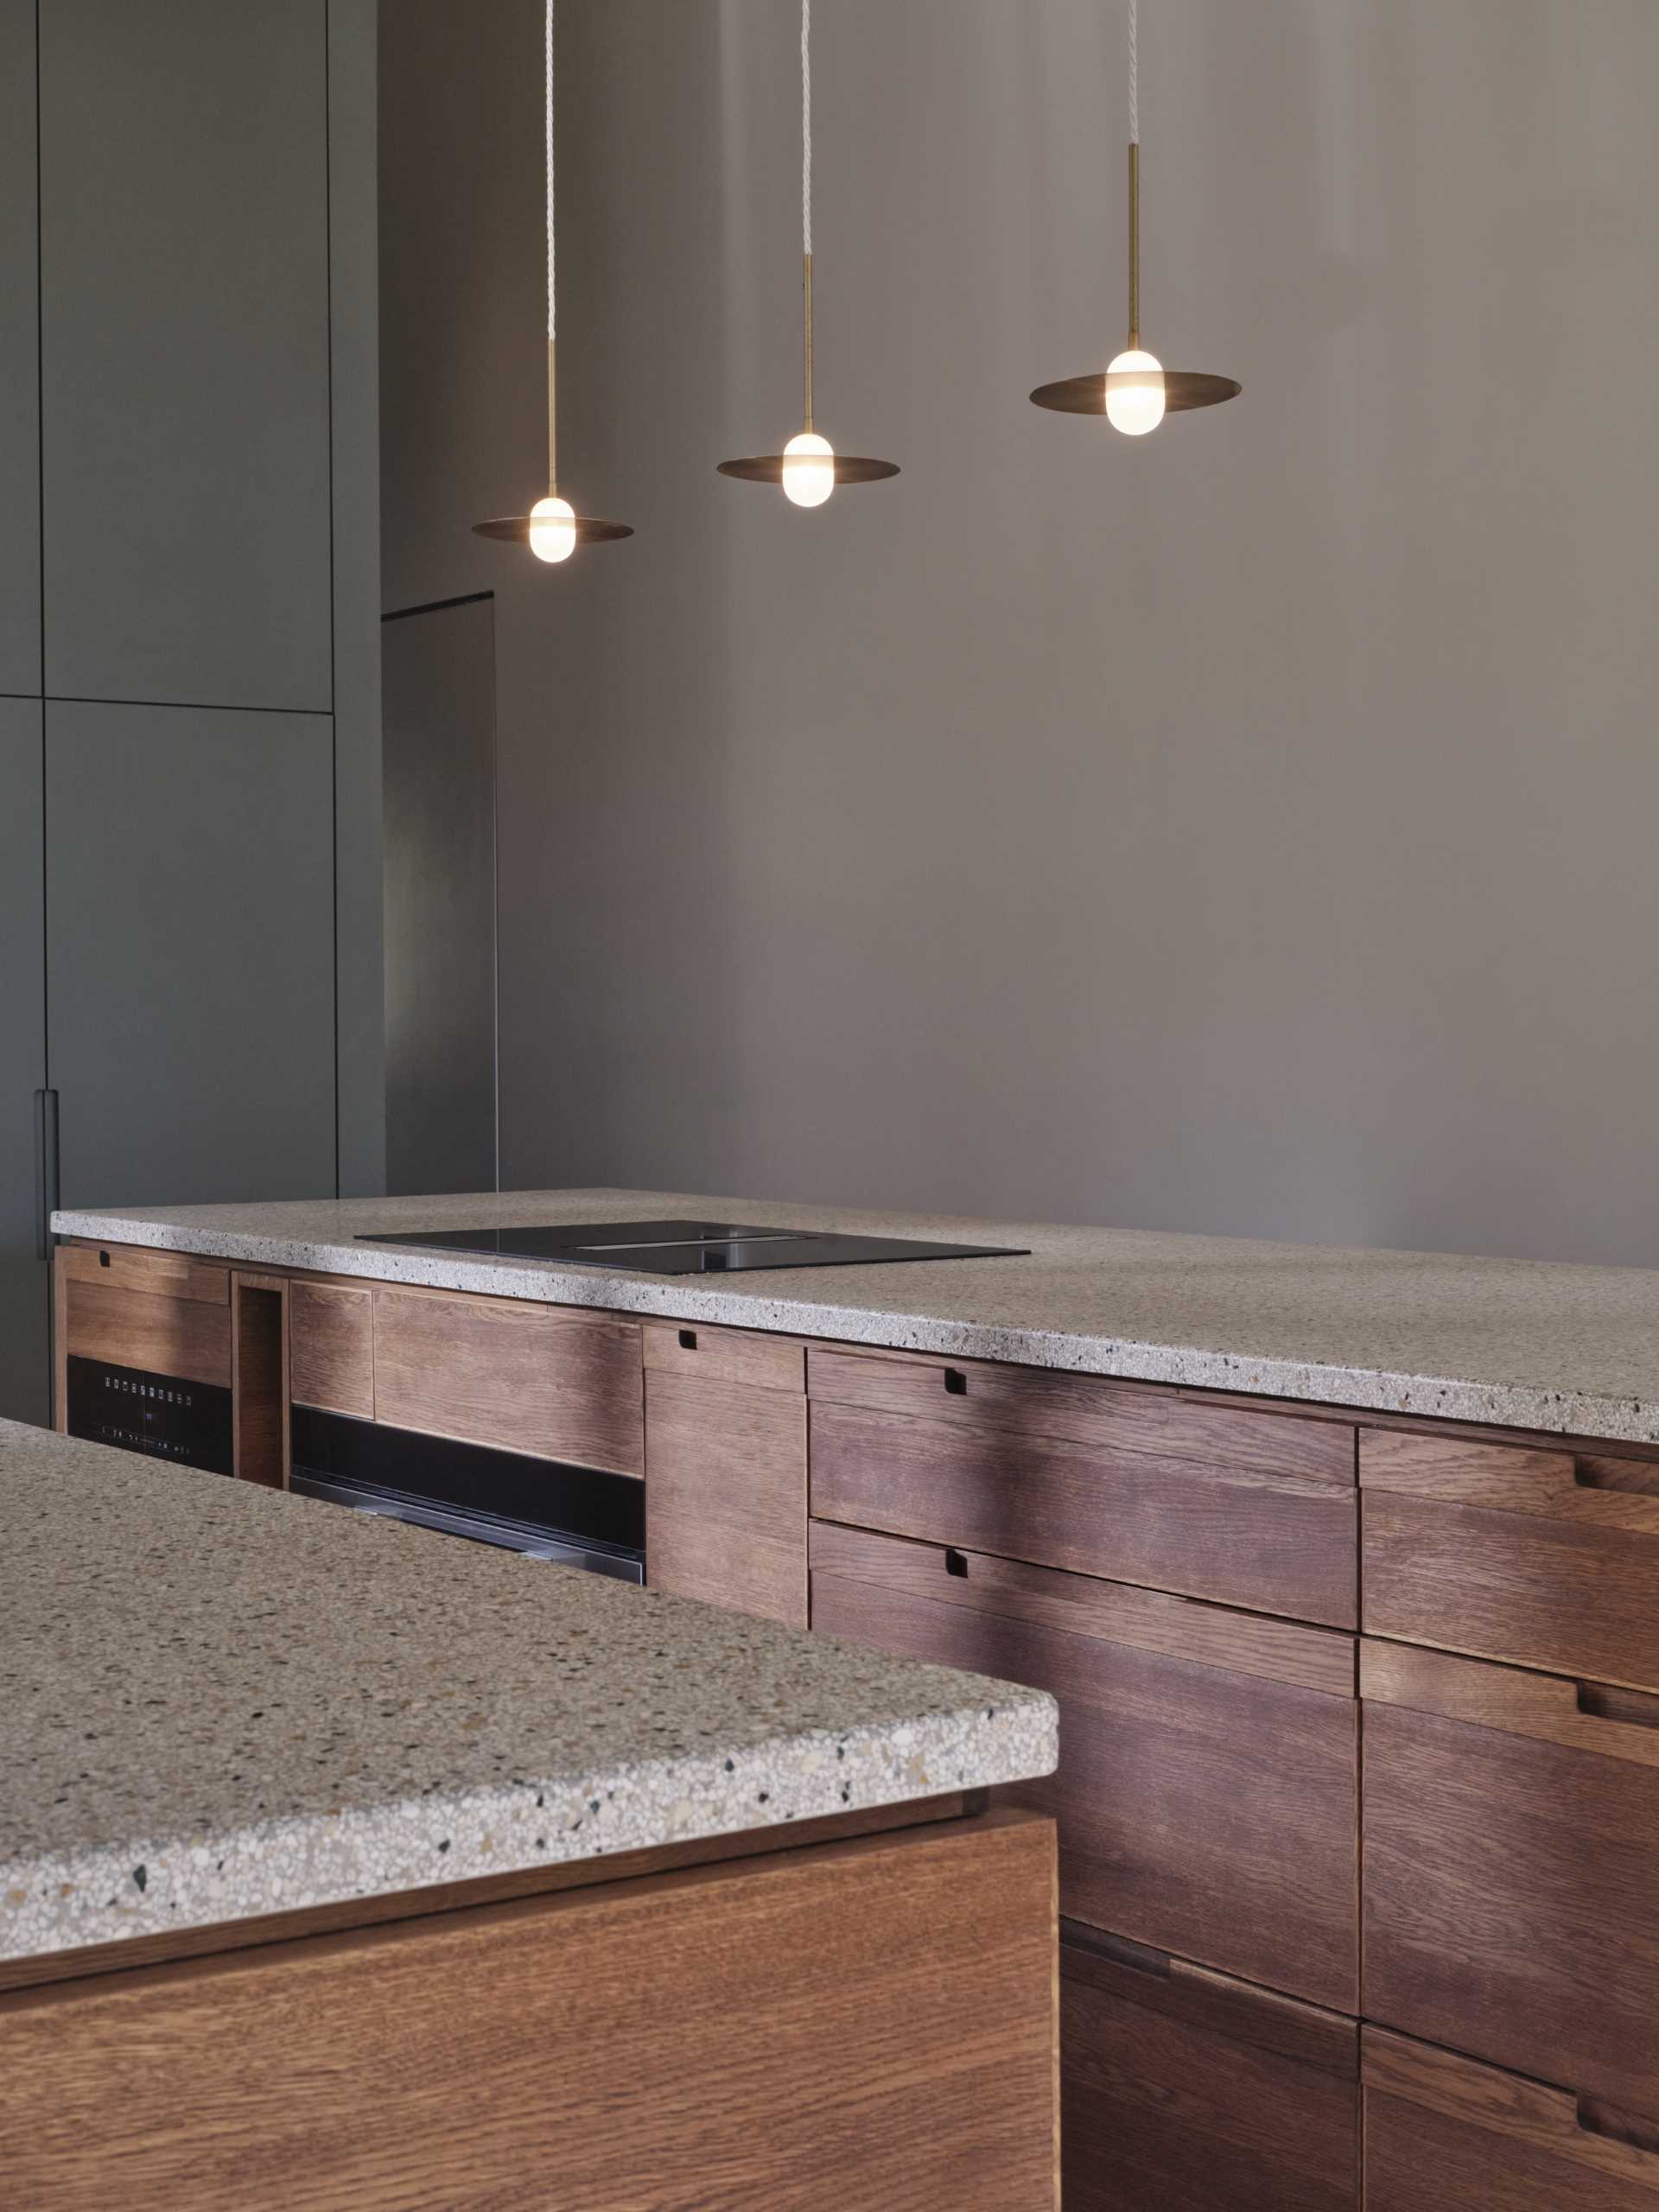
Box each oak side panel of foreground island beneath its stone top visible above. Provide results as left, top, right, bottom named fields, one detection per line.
left=0, top=1814, right=1058, bottom=2212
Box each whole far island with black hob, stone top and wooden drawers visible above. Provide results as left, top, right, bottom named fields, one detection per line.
left=41, top=1190, right=1659, bottom=2212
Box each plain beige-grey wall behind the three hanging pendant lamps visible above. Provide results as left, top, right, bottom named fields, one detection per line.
left=387, top=0, right=1659, bottom=1263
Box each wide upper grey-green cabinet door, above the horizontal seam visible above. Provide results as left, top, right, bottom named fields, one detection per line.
left=38, top=0, right=334, bottom=712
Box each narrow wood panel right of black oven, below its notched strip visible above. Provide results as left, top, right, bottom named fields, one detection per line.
left=646, top=1370, right=807, bottom=1628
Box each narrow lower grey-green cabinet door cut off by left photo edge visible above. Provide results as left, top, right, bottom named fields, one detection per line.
left=0, top=699, right=48, bottom=1422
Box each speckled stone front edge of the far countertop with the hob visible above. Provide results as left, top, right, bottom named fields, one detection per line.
left=53, top=1210, right=1659, bottom=1445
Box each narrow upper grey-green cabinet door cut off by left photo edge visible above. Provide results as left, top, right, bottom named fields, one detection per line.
left=0, top=0, right=40, bottom=694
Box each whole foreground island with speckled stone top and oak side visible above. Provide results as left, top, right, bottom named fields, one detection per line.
left=0, top=1422, right=1055, bottom=2212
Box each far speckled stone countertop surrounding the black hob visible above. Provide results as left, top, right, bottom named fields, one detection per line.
left=55, top=1190, right=1659, bottom=1445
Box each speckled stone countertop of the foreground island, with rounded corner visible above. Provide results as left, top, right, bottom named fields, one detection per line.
left=0, top=1422, right=1058, bottom=1973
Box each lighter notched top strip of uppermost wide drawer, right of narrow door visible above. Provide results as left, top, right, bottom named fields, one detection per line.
left=807, top=1350, right=1354, bottom=1484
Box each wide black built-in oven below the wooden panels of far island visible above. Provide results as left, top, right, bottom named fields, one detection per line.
left=289, top=1405, right=646, bottom=1581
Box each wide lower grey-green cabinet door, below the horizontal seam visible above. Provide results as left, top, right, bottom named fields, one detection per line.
left=47, top=702, right=334, bottom=1205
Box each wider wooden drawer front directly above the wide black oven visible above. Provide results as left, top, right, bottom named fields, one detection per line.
left=374, top=1289, right=646, bottom=1476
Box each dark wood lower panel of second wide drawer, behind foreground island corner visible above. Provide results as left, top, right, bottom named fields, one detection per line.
left=812, top=1553, right=1358, bottom=2011
